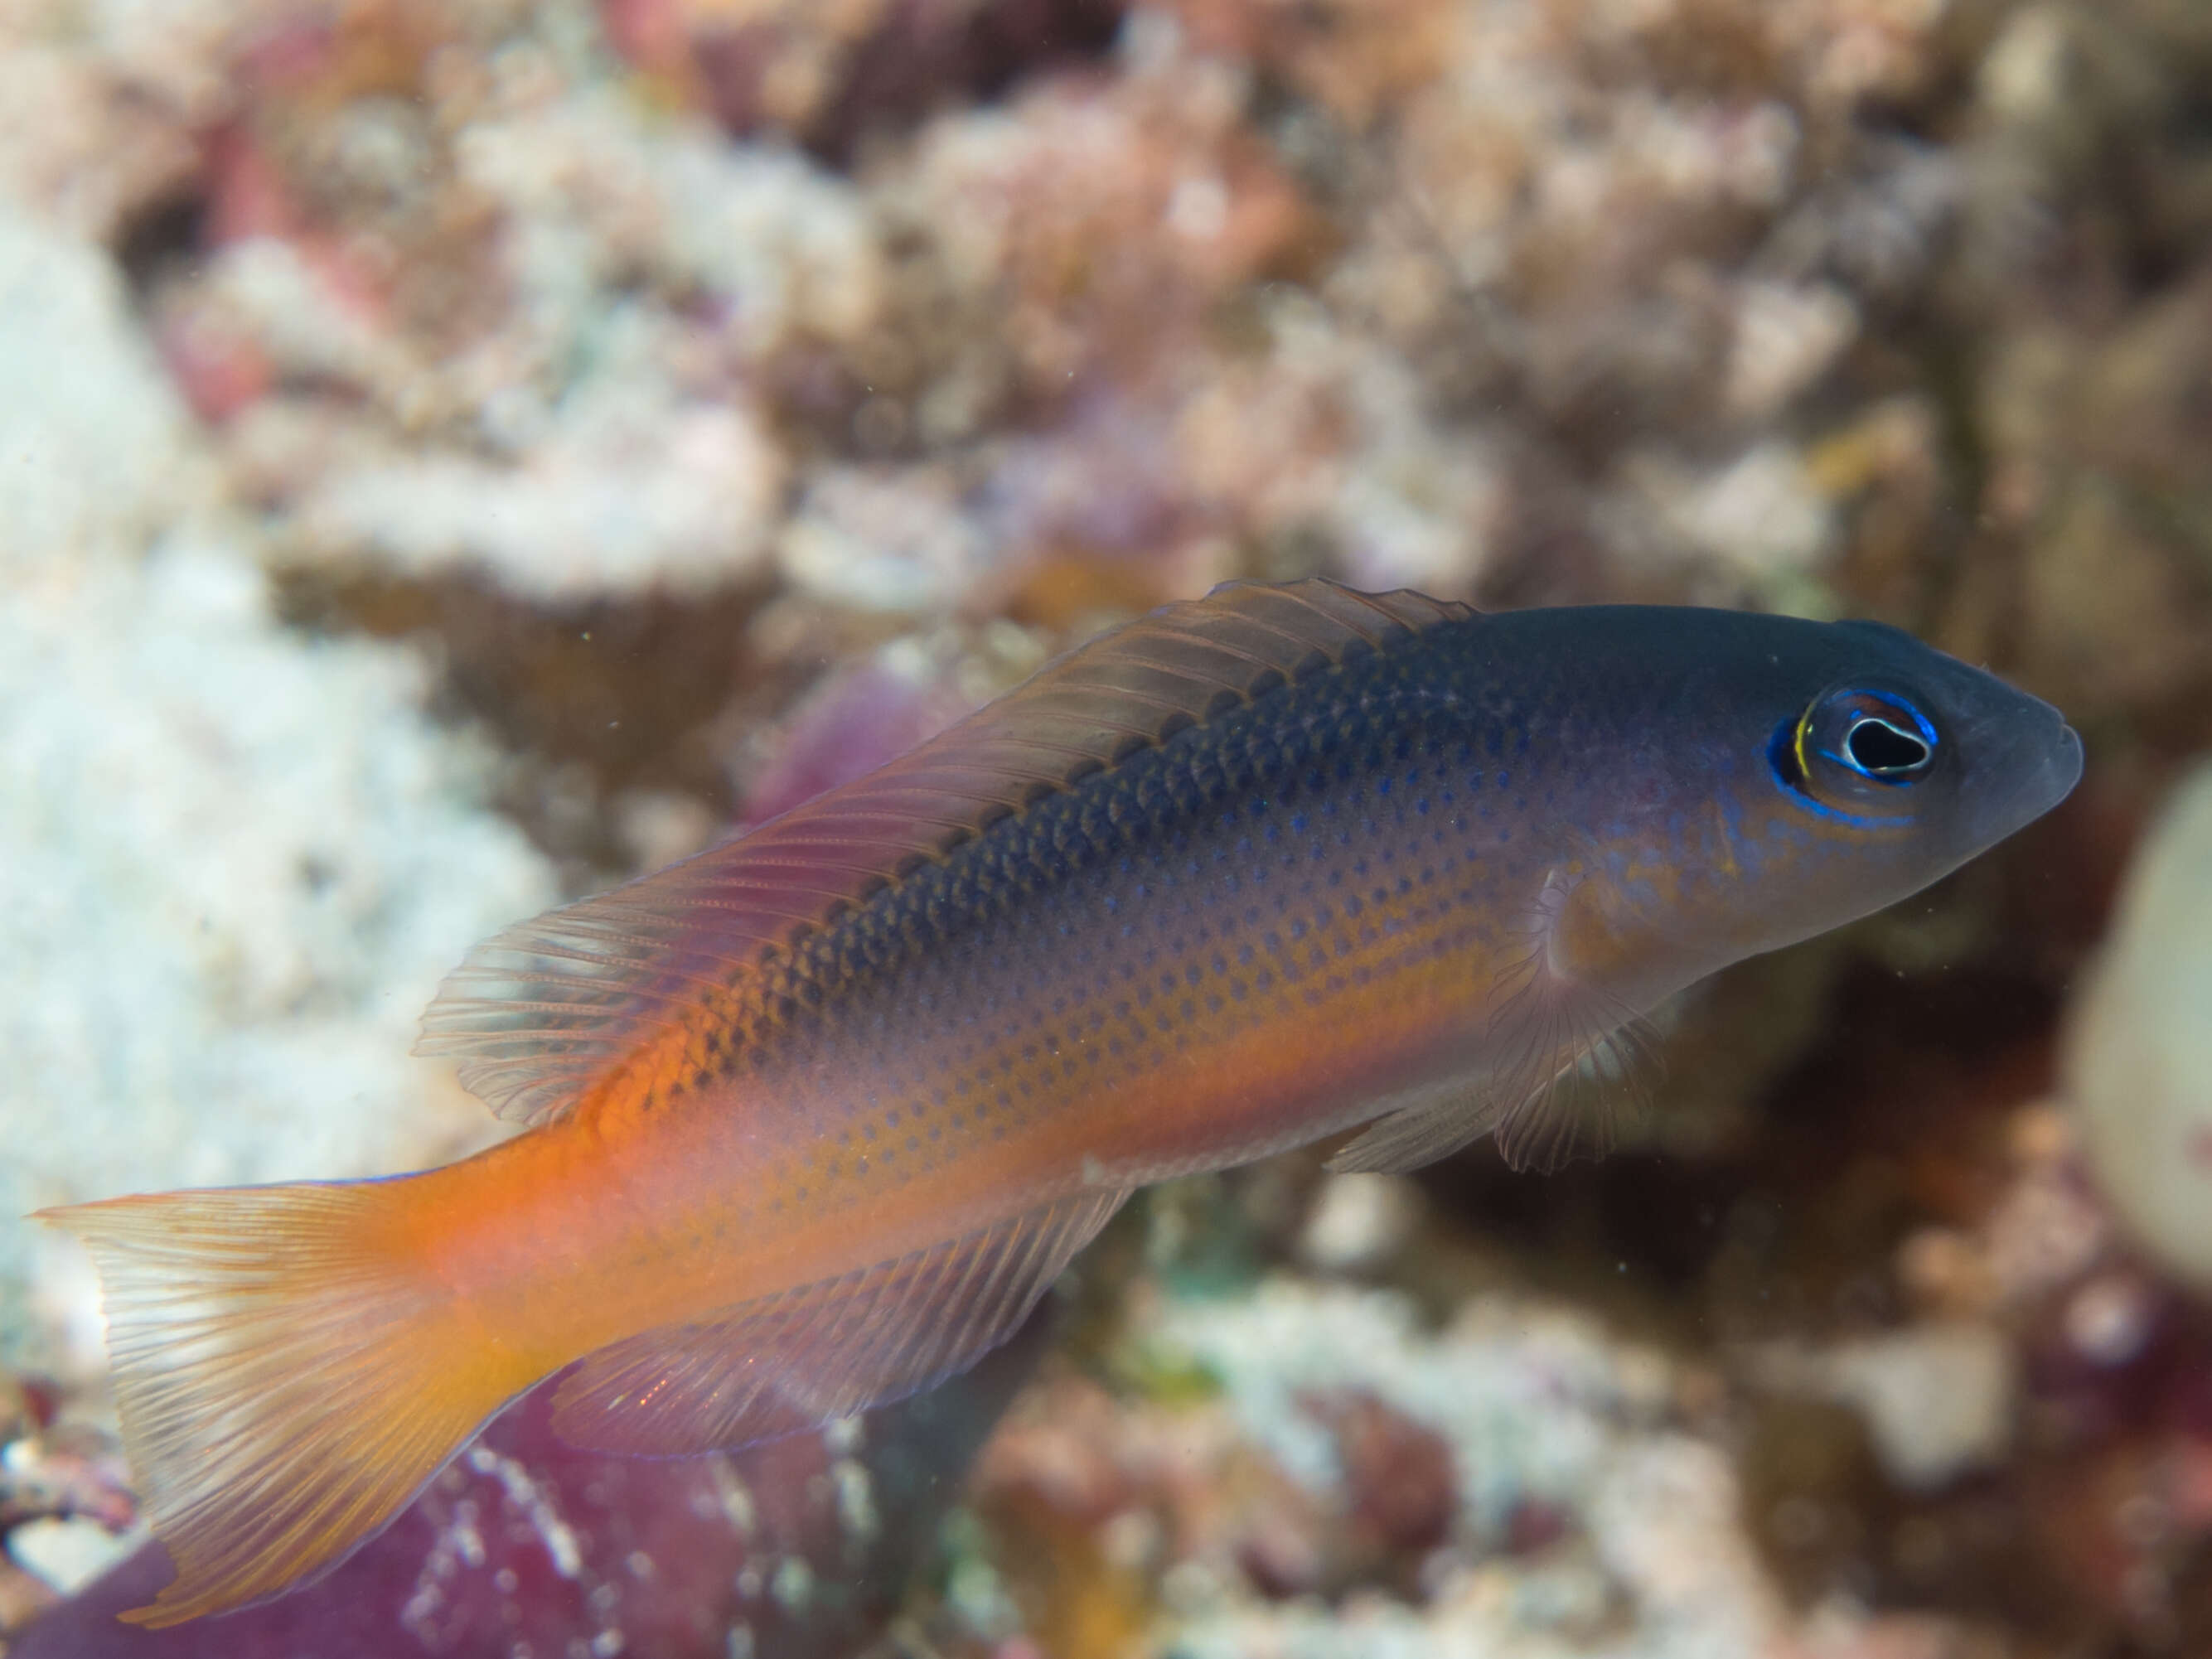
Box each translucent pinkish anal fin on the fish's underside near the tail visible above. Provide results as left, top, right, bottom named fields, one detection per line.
left=553, top=1190, right=1128, bottom=1458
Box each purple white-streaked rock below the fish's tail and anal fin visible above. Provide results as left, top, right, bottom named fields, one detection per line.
left=9, top=1314, right=1051, bottom=1659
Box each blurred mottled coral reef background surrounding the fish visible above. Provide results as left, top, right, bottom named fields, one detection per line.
left=0, top=0, right=2212, bottom=1659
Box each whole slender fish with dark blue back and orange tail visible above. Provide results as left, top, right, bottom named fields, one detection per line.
left=40, top=579, right=2082, bottom=1628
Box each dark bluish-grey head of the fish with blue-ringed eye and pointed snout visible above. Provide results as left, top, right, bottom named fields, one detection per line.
left=1681, top=617, right=2082, bottom=958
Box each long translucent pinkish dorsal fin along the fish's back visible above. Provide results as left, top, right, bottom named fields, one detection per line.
left=416, top=579, right=1474, bottom=1124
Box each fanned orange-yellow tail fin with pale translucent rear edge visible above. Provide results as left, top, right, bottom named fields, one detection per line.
left=40, top=1181, right=533, bottom=1628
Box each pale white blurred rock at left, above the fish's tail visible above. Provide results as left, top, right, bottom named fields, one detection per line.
left=0, top=206, right=551, bottom=1367
